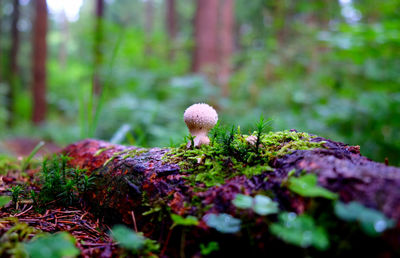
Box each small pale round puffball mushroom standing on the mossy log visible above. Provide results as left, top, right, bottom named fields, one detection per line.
left=183, top=103, right=218, bottom=147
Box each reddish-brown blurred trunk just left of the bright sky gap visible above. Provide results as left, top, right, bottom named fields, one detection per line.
left=32, top=0, right=47, bottom=125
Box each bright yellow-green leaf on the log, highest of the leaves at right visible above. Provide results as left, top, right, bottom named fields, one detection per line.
left=288, top=174, right=338, bottom=200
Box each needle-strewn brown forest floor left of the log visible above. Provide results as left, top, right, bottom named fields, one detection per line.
left=0, top=138, right=118, bottom=257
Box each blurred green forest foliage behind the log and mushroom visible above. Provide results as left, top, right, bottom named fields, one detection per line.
left=0, top=0, right=400, bottom=165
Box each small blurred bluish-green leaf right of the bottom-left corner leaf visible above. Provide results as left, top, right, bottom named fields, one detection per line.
left=112, top=225, right=146, bottom=252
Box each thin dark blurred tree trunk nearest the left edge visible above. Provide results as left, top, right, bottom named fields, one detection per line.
left=6, top=0, right=20, bottom=127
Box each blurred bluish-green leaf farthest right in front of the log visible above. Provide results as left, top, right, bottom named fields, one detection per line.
left=335, top=202, right=395, bottom=236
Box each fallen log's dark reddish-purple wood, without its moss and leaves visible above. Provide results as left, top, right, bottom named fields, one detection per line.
left=63, top=137, right=400, bottom=257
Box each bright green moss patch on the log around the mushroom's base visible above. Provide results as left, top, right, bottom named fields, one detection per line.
left=164, top=128, right=325, bottom=189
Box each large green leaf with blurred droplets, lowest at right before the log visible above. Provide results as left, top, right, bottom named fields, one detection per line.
left=270, top=212, right=329, bottom=250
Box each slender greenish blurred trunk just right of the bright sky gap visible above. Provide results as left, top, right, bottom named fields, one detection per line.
left=93, top=0, right=104, bottom=96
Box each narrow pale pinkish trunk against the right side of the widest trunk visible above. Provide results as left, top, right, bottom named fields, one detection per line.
left=217, top=0, right=235, bottom=97
